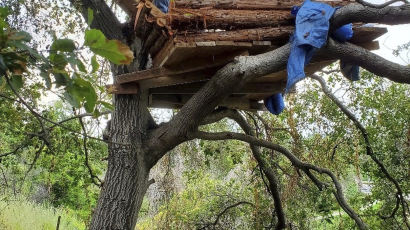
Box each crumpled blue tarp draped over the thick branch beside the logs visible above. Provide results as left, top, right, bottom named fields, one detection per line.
left=264, top=0, right=359, bottom=115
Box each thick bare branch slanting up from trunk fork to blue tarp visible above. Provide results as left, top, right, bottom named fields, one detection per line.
left=147, top=44, right=290, bottom=165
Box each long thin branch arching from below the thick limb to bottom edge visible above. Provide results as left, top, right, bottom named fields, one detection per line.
left=188, top=131, right=368, bottom=230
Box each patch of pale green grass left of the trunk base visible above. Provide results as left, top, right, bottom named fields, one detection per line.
left=0, top=197, right=85, bottom=230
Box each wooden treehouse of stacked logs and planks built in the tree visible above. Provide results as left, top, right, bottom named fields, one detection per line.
left=108, top=0, right=387, bottom=111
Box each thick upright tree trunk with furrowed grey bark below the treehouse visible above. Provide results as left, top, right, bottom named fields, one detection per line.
left=90, top=39, right=152, bottom=230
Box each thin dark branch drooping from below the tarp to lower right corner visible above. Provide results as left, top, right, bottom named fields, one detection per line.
left=310, top=74, right=410, bottom=228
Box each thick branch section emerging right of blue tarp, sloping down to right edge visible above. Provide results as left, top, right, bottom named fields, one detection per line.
left=325, top=38, right=410, bottom=84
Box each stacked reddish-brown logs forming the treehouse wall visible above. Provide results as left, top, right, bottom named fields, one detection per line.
left=134, top=0, right=356, bottom=60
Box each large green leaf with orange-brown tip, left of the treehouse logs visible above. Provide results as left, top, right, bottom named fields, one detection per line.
left=84, top=29, right=134, bottom=65
